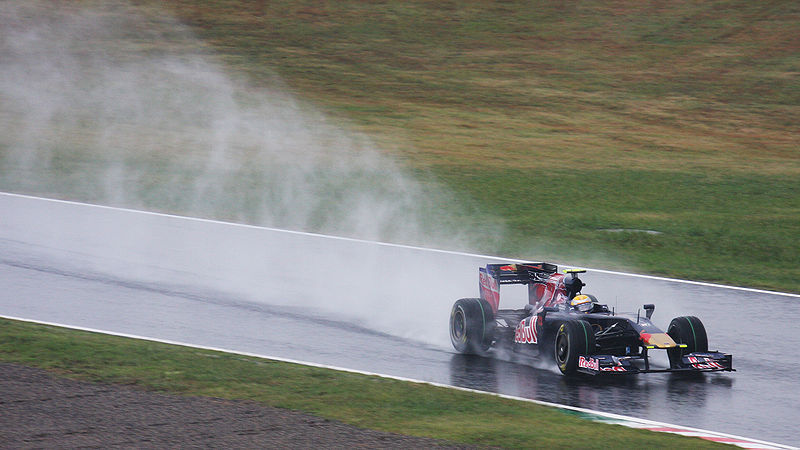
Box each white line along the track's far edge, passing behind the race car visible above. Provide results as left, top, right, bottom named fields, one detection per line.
left=0, top=192, right=800, bottom=298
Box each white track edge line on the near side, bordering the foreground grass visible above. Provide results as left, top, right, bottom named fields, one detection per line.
left=0, top=314, right=796, bottom=450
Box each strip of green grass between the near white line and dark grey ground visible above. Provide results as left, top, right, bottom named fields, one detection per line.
left=0, top=319, right=721, bottom=448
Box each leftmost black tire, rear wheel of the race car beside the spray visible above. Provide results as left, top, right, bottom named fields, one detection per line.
left=450, top=298, right=495, bottom=355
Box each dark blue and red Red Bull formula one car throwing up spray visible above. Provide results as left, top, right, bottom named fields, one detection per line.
left=450, top=262, right=734, bottom=375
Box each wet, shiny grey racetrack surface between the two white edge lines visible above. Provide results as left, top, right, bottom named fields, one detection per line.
left=0, top=195, right=800, bottom=446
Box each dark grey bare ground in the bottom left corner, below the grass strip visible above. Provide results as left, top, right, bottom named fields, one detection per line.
left=0, top=363, right=465, bottom=448
